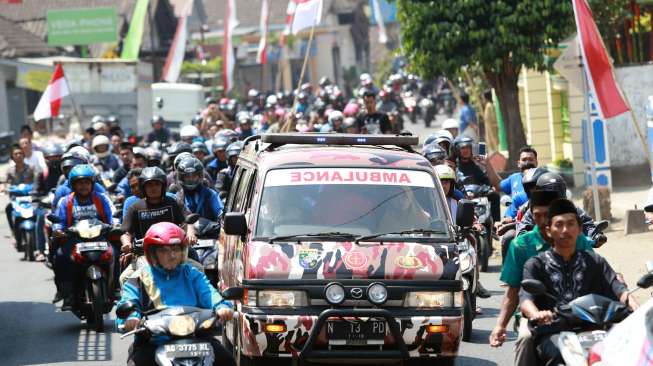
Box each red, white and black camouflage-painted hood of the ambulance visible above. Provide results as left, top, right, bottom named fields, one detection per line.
left=245, top=242, right=459, bottom=280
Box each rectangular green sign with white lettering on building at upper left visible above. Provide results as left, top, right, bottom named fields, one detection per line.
left=47, top=8, right=118, bottom=46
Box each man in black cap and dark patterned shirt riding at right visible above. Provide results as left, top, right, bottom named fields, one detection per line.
left=519, top=199, right=638, bottom=364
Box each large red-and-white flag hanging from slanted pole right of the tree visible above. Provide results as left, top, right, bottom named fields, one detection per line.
left=572, top=0, right=628, bottom=118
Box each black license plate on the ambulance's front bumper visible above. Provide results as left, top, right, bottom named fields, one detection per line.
left=327, top=320, right=386, bottom=346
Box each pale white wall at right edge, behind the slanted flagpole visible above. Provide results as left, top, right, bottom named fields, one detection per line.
left=607, top=65, right=653, bottom=167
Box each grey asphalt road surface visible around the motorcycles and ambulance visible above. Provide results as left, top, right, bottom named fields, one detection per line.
left=0, top=114, right=514, bottom=366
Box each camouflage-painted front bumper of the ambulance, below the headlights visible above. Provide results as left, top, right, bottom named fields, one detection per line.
left=242, top=314, right=462, bottom=357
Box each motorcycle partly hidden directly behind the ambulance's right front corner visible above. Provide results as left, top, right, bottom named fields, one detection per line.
left=458, top=236, right=478, bottom=342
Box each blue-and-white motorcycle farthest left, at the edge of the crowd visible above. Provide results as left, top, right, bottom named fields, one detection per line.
left=9, top=184, right=36, bottom=262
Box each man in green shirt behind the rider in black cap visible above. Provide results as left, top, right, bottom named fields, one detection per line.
left=490, top=191, right=593, bottom=365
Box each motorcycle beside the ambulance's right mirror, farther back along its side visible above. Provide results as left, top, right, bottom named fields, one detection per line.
left=461, top=183, right=494, bottom=272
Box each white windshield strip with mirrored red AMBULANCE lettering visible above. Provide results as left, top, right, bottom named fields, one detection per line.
left=265, top=168, right=435, bottom=188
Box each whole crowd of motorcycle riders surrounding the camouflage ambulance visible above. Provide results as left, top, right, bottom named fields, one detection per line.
left=0, top=68, right=637, bottom=365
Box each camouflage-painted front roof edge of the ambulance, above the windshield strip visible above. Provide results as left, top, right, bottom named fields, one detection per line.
left=246, top=145, right=433, bottom=172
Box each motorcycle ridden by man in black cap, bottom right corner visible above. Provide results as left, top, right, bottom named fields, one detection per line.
left=521, top=273, right=653, bottom=365
